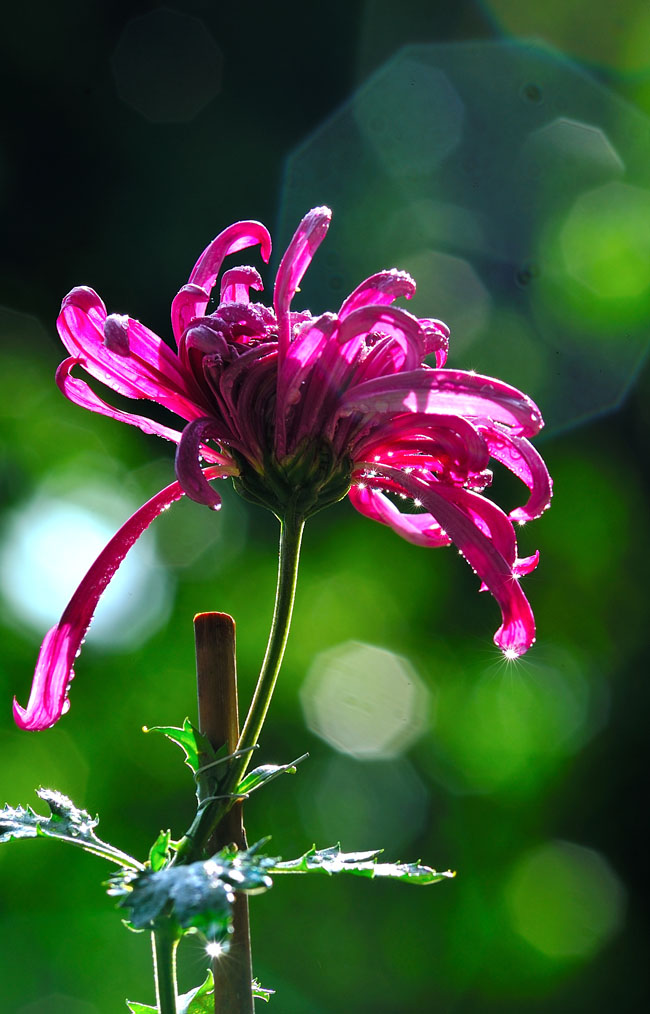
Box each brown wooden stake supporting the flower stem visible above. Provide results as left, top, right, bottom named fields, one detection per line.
left=194, top=612, right=254, bottom=1014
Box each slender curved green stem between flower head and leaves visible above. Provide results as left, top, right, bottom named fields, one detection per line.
left=174, top=514, right=304, bottom=863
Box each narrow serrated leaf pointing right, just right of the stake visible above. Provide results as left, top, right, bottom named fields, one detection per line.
left=268, top=845, right=455, bottom=884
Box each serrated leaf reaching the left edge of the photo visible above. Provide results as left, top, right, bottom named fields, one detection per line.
left=0, top=789, right=142, bottom=869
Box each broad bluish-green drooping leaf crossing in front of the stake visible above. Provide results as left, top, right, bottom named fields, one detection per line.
left=109, top=849, right=275, bottom=940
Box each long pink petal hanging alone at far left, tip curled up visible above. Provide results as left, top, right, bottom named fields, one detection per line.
left=13, top=466, right=228, bottom=729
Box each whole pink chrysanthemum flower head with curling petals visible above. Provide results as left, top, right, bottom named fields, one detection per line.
left=14, top=208, right=551, bottom=729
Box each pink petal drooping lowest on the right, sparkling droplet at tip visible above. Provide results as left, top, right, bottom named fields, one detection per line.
left=368, top=464, right=534, bottom=657
